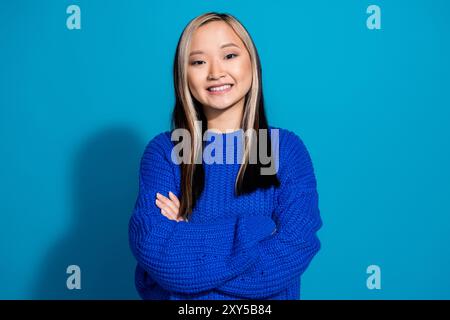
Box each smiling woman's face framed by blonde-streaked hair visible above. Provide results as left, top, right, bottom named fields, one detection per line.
left=187, top=21, right=252, bottom=111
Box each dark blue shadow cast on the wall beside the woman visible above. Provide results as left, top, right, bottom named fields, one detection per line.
left=33, top=128, right=145, bottom=299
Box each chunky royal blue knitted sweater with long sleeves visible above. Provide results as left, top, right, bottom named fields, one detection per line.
left=129, top=127, right=322, bottom=300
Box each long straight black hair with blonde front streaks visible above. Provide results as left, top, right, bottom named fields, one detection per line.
left=172, top=12, right=280, bottom=218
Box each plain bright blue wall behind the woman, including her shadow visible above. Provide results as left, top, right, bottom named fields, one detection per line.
left=0, top=0, right=450, bottom=299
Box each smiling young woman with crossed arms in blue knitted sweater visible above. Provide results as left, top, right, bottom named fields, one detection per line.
left=129, top=13, right=322, bottom=300
